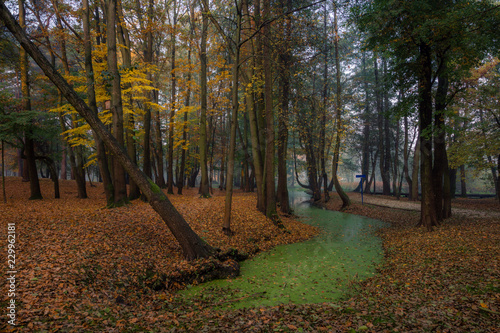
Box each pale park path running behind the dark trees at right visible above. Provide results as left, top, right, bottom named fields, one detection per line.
left=349, top=193, right=500, bottom=220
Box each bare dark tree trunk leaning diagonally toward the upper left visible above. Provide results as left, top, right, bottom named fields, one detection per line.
left=0, top=2, right=214, bottom=260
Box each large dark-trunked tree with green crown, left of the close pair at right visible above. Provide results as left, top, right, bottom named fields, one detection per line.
left=357, top=0, right=500, bottom=230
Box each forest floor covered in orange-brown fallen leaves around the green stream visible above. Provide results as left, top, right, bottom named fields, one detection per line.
left=0, top=178, right=500, bottom=332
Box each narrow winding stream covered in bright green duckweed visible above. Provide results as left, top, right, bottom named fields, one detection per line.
left=182, top=191, right=383, bottom=308
